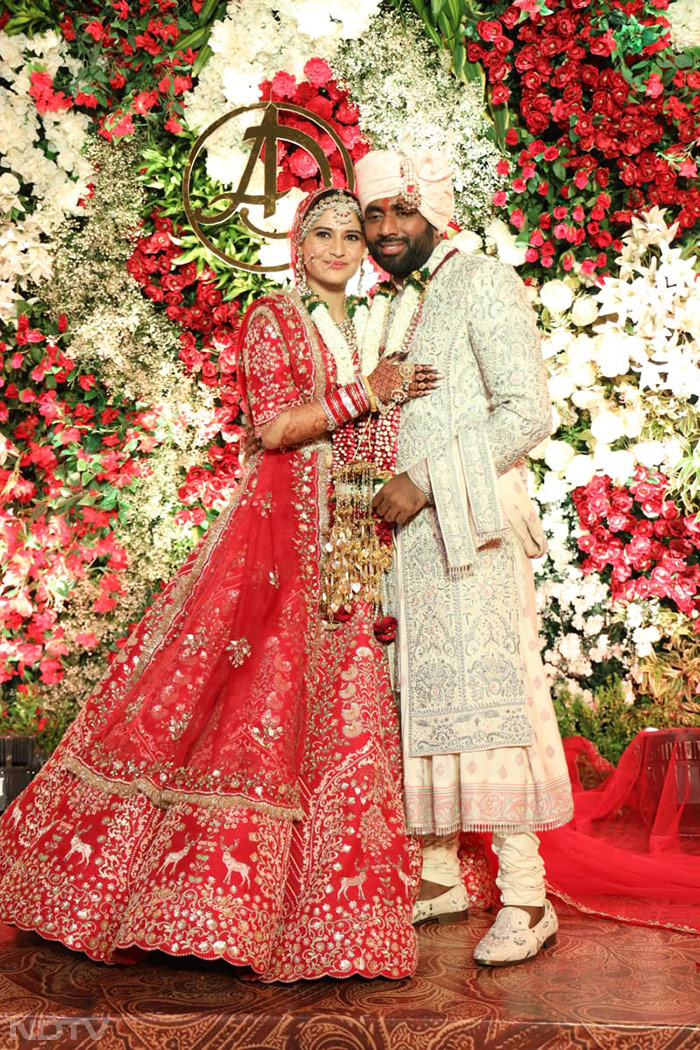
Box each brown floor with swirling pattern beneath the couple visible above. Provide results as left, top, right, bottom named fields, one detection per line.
left=0, top=905, right=700, bottom=1050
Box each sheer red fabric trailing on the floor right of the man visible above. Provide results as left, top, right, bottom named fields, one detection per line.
left=540, top=729, right=700, bottom=932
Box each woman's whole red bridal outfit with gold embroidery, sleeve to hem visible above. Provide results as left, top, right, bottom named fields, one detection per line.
left=0, top=277, right=420, bottom=981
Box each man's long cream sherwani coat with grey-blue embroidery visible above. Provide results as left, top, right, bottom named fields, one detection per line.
left=389, top=242, right=571, bottom=835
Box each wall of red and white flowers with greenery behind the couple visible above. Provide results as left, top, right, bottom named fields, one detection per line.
left=0, top=0, right=700, bottom=758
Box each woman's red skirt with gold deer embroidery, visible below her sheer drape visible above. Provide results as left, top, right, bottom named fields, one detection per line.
left=0, top=609, right=420, bottom=981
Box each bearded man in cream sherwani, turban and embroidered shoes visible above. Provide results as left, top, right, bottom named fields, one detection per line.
left=357, top=150, right=572, bottom=966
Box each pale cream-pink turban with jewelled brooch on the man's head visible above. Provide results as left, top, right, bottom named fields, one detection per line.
left=355, top=143, right=454, bottom=233
